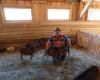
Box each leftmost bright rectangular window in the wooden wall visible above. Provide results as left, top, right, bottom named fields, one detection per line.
left=4, top=8, right=32, bottom=21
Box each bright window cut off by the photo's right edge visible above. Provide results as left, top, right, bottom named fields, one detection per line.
left=88, top=9, right=100, bottom=21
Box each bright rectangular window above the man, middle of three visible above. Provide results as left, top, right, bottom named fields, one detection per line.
left=48, top=9, right=69, bottom=20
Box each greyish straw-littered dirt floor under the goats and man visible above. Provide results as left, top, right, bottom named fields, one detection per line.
left=0, top=49, right=100, bottom=80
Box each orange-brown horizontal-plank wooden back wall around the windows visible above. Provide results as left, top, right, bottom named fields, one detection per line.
left=0, top=0, right=100, bottom=47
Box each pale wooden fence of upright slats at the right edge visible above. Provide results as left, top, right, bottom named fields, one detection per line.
left=77, top=31, right=100, bottom=54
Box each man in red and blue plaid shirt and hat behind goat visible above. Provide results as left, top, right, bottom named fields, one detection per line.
left=46, top=27, right=71, bottom=61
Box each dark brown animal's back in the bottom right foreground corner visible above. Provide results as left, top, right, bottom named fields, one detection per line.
left=74, top=65, right=100, bottom=80
